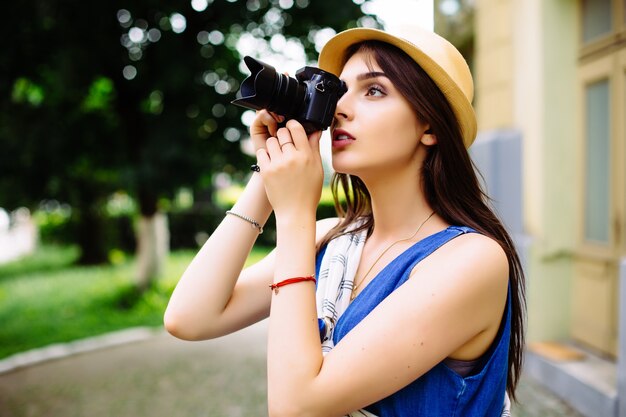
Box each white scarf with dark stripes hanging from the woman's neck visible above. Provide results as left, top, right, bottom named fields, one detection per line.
left=315, top=223, right=511, bottom=417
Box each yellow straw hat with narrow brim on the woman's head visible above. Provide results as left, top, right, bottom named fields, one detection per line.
left=319, top=26, right=476, bottom=148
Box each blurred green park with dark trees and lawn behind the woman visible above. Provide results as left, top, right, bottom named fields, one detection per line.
left=0, top=0, right=472, bottom=357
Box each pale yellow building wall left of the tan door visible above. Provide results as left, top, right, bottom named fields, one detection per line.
left=474, top=0, right=577, bottom=342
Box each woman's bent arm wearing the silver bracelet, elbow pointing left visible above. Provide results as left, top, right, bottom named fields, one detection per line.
left=164, top=173, right=274, bottom=340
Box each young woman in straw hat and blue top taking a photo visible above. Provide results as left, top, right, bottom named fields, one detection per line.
left=165, top=28, right=525, bottom=417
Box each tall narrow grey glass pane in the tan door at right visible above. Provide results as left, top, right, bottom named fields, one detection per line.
left=585, top=79, right=611, bottom=243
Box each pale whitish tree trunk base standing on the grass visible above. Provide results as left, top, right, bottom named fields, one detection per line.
left=136, top=212, right=169, bottom=291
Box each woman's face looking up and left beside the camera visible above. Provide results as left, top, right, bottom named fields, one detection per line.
left=332, top=52, right=428, bottom=179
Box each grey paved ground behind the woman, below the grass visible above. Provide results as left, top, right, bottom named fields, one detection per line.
left=0, top=323, right=582, bottom=417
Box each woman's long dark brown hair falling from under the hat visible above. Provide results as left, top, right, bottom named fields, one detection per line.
left=319, top=41, right=526, bottom=400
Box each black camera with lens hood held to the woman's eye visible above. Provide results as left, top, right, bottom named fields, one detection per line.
left=232, top=56, right=347, bottom=134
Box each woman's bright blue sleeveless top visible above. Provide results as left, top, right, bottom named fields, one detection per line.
left=317, top=226, right=511, bottom=417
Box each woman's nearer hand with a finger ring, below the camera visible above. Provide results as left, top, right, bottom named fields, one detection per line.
left=256, top=119, right=324, bottom=218
